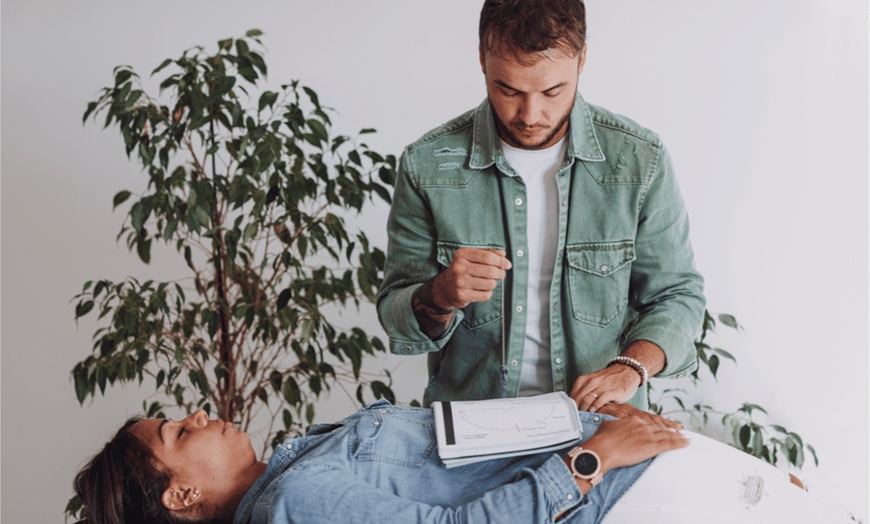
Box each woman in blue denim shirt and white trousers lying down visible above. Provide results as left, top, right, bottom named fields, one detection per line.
left=75, top=401, right=853, bottom=524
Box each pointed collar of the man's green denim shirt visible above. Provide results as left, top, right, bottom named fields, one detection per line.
left=469, top=92, right=604, bottom=172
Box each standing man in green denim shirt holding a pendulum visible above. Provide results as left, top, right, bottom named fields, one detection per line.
left=378, top=0, right=705, bottom=411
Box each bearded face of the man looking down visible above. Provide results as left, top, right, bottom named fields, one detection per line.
left=480, top=47, right=586, bottom=149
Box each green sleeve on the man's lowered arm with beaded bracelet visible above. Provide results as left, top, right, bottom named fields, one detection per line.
left=623, top=143, right=706, bottom=377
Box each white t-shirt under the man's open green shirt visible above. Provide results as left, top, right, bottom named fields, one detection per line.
left=501, top=136, right=568, bottom=396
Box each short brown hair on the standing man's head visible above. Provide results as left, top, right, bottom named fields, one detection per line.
left=479, top=0, right=586, bottom=58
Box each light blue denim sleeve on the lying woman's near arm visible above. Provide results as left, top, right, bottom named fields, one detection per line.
left=270, top=455, right=587, bottom=524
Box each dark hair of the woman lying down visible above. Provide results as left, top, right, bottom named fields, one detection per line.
left=73, top=418, right=218, bottom=524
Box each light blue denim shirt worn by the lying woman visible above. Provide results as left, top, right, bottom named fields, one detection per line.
left=233, top=400, right=650, bottom=524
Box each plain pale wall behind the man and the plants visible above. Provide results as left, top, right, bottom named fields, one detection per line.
left=2, top=0, right=870, bottom=524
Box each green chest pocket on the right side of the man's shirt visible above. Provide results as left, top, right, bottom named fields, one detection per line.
left=565, top=240, right=635, bottom=326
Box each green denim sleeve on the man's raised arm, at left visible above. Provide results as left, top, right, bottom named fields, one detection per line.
left=378, top=153, right=463, bottom=355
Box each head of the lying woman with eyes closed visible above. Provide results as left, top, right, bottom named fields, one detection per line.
left=74, top=410, right=265, bottom=524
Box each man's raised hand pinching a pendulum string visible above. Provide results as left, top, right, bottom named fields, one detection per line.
left=432, top=247, right=511, bottom=309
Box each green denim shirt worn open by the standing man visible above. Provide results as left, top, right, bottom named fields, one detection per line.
left=378, top=94, right=705, bottom=408
